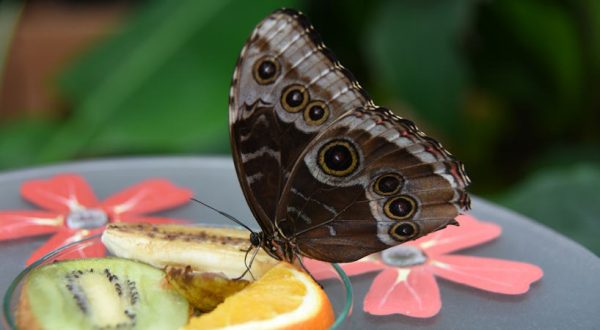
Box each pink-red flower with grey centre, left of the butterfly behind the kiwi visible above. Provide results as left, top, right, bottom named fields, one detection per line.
left=0, top=174, right=192, bottom=265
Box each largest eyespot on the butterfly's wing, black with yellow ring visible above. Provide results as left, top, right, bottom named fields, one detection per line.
left=319, top=140, right=358, bottom=176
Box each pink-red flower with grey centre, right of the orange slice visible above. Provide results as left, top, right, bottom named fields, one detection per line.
left=306, top=215, right=543, bottom=318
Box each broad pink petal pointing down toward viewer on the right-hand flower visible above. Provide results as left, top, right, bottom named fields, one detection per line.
left=363, top=266, right=442, bottom=318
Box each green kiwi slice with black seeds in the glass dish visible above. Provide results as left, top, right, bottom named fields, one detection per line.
left=17, top=258, right=189, bottom=329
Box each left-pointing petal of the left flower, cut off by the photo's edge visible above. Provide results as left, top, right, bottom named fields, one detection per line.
left=0, top=211, right=64, bottom=241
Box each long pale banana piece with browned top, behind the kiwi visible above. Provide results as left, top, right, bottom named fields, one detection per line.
left=102, top=223, right=278, bottom=280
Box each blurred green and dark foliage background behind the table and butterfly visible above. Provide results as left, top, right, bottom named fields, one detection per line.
left=0, top=0, right=600, bottom=255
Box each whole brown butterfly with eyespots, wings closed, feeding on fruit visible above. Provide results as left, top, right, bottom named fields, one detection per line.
left=229, top=9, right=470, bottom=262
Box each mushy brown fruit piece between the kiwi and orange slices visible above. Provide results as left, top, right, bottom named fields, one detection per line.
left=165, top=266, right=249, bottom=312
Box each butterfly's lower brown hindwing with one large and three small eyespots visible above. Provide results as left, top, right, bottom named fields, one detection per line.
left=276, top=108, right=469, bottom=262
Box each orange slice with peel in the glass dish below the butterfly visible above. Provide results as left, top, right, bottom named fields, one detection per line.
left=184, top=262, right=334, bottom=330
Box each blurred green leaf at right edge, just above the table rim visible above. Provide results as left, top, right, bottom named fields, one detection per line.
left=499, top=164, right=600, bottom=255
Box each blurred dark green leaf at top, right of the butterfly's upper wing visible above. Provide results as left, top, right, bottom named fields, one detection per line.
left=365, top=0, right=473, bottom=135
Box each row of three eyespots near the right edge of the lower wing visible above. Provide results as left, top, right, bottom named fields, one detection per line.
left=373, top=173, right=419, bottom=242
